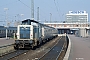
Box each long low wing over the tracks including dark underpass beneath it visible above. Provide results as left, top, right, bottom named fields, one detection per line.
left=44, top=23, right=90, bottom=34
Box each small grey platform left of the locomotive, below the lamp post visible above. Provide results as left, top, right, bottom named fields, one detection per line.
left=0, top=38, right=15, bottom=47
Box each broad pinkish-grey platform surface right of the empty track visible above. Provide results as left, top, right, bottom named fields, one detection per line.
left=69, top=35, right=90, bottom=60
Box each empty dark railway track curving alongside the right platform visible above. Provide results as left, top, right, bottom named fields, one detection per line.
left=39, top=36, right=65, bottom=60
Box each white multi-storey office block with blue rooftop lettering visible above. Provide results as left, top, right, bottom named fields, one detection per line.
left=66, top=11, right=88, bottom=23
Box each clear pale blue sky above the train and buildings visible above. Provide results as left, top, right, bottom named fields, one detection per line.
left=0, top=0, right=90, bottom=26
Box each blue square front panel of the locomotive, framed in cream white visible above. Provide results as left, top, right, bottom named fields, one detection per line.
left=20, top=27, right=30, bottom=39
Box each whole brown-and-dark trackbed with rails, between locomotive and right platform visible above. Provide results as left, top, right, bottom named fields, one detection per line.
left=0, top=36, right=65, bottom=60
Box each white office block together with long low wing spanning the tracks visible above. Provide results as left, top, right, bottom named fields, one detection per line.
left=44, top=11, right=90, bottom=35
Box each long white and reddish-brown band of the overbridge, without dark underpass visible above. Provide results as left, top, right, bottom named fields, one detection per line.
left=44, top=22, right=90, bottom=29
